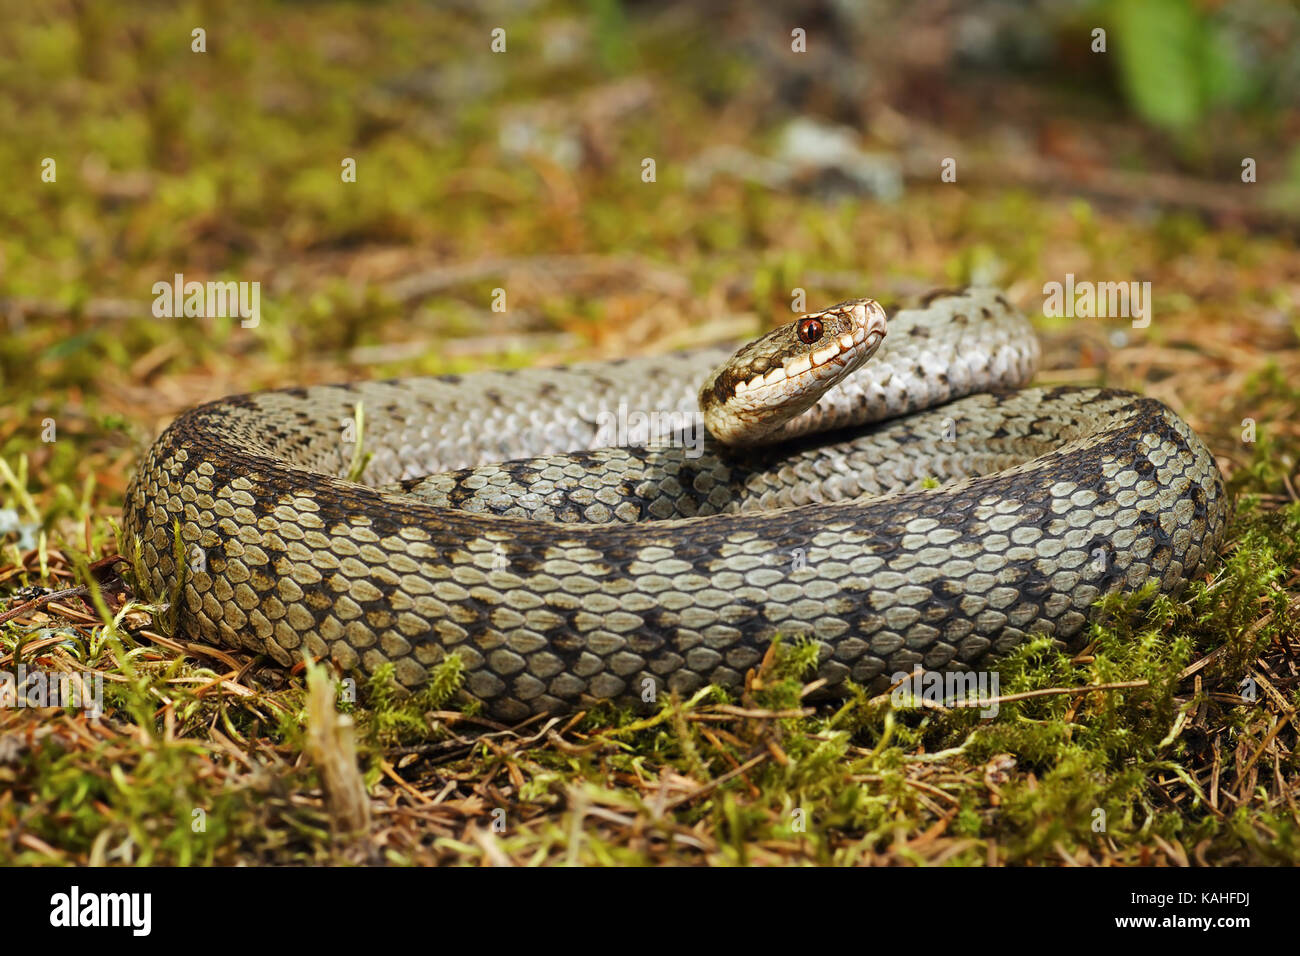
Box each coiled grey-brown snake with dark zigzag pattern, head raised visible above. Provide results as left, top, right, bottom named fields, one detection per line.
left=124, top=287, right=1230, bottom=721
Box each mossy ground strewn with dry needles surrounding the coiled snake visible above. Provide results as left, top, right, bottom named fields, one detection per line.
left=0, top=4, right=1300, bottom=865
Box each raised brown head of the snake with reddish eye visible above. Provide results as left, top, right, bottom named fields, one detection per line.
left=699, top=299, right=885, bottom=445
